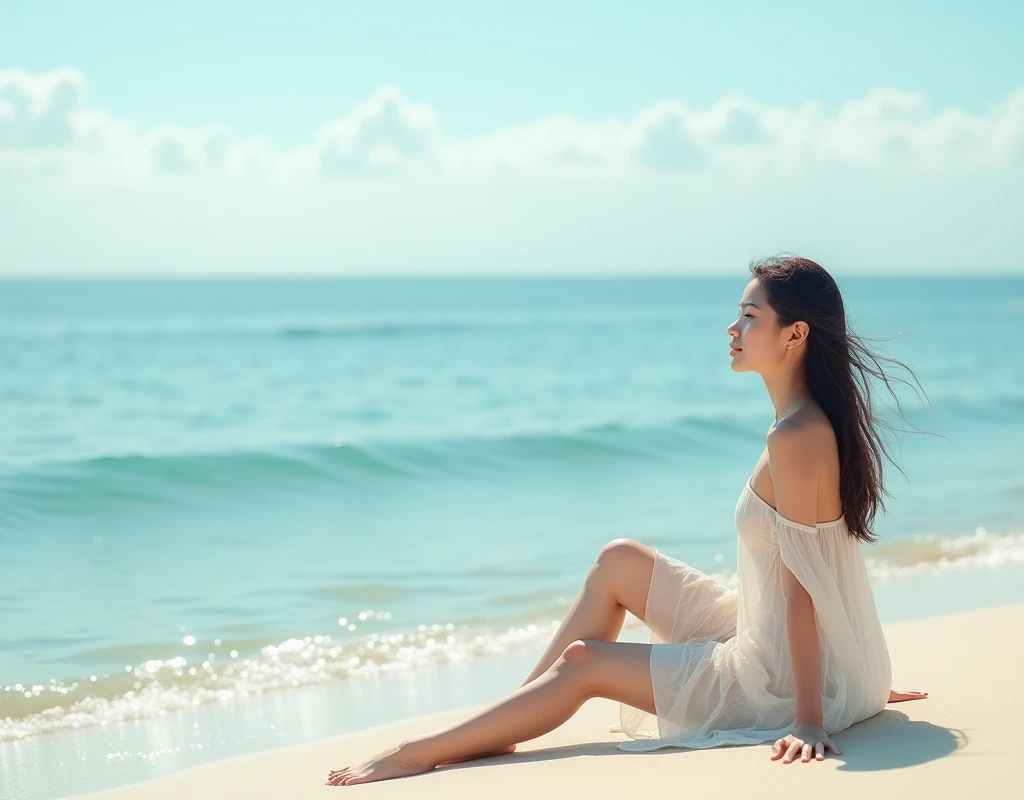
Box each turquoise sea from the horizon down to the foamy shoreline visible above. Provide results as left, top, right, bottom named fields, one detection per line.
left=0, top=271, right=1024, bottom=797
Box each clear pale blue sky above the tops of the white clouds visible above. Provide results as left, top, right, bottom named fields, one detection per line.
left=0, top=0, right=1024, bottom=146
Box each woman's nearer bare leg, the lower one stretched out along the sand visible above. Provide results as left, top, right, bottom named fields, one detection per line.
left=328, top=640, right=656, bottom=786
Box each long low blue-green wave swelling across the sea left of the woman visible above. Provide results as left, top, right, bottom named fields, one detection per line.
left=0, top=416, right=753, bottom=524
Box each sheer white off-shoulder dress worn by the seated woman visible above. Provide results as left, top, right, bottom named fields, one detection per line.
left=609, top=479, right=892, bottom=751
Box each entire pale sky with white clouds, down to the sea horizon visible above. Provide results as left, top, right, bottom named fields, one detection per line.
left=0, top=0, right=1024, bottom=278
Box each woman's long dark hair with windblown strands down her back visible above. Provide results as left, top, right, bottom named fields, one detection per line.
left=751, top=255, right=927, bottom=542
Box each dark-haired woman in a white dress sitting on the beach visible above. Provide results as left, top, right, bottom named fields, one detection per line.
left=328, top=257, right=927, bottom=786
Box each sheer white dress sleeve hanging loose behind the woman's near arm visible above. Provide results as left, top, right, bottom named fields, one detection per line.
left=772, top=511, right=890, bottom=728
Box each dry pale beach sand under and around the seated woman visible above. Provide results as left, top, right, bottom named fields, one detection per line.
left=76, top=604, right=1024, bottom=800
